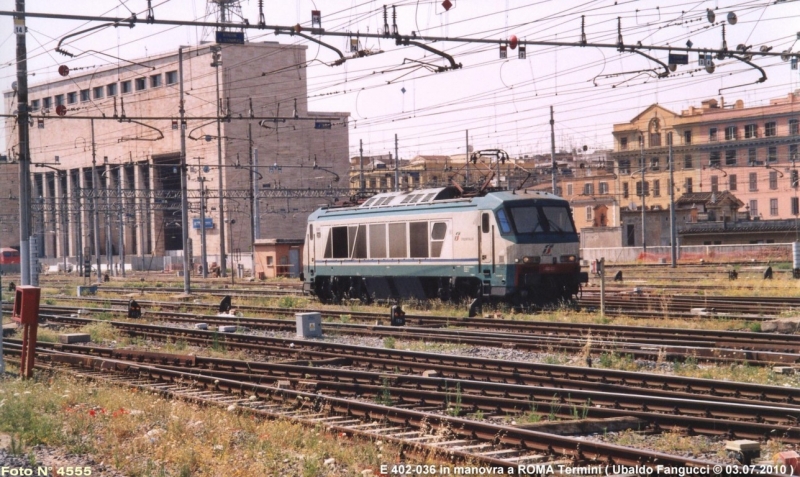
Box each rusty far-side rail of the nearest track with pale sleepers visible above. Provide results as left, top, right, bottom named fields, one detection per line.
left=0, top=342, right=780, bottom=470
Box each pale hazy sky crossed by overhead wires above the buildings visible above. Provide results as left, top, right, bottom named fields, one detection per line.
left=0, top=0, right=800, bottom=158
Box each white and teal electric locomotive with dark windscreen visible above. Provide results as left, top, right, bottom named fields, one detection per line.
left=303, top=186, right=588, bottom=305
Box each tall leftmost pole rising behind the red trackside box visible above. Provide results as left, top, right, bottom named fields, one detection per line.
left=14, top=0, right=31, bottom=285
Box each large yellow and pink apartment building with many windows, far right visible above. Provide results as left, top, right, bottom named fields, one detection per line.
left=612, top=92, right=800, bottom=246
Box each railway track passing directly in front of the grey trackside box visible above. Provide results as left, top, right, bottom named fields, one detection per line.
left=7, top=314, right=800, bottom=404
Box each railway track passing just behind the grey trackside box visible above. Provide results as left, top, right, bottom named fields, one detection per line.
left=25, top=303, right=800, bottom=366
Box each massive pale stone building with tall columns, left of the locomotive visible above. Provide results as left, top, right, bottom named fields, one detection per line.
left=0, top=42, right=349, bottom=268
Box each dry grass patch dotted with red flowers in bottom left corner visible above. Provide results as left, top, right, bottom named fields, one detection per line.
left=0, top=375, right=412, bottom=477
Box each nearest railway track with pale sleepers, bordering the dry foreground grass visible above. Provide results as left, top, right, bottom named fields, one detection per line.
left=0, top=343, right=794, bottom=468
